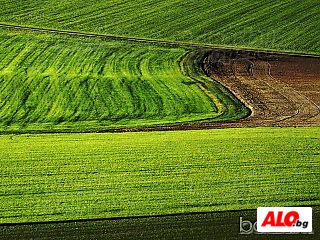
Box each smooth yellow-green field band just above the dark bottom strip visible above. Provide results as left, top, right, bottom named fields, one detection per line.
left=0, top=127, right=320, bottom=223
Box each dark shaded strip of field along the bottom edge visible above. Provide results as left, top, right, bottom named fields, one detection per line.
left=0, top=206, right=320, bottom=239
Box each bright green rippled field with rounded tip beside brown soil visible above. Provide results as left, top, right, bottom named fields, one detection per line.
left=0, top=30, right=249, bottom=132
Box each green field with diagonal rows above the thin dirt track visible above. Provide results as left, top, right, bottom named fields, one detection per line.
left=0, top=0, right=320, bottom=54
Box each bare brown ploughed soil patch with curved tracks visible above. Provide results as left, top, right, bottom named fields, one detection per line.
left=203, top=50, right=320, bottom=127
